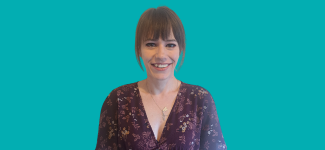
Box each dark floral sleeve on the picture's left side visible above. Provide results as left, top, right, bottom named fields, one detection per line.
left=95, top=90, right=118, bottom=150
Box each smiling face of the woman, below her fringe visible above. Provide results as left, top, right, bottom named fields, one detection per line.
left=140, top=32, right=180, bottom=80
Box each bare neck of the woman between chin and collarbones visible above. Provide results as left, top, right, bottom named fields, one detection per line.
left=145, top=76, right=179, bottom=95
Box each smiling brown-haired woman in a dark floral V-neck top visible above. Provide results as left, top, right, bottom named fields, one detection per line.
left=96, top=7, right=227, bottom=150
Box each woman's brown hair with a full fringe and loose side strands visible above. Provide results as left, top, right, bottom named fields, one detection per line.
left=135, top=6, right=185, bottom=71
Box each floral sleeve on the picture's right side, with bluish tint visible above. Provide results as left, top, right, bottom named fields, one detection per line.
left=200, top=92, right=227, bottom=150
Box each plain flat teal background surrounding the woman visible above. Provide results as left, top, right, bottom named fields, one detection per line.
left=0, top=0, right=325, bottom=150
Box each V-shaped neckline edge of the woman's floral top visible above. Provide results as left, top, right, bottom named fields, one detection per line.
left=136, top=81, right=183, bottom=144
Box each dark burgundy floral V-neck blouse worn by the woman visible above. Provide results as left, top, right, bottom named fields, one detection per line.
left=96, top=82, right=227, bottom=150
